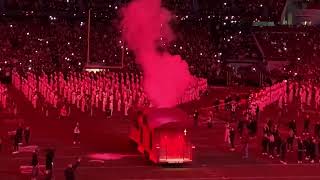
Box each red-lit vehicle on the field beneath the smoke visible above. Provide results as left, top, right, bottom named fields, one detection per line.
left=129, top=108, right=194, bottom=164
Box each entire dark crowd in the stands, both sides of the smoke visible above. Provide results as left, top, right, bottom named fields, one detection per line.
left=0, top=0, right=320, bottom=88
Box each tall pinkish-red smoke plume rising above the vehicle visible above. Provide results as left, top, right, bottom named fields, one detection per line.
left=121, top=0, right=192, bottom=107
